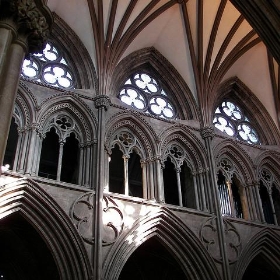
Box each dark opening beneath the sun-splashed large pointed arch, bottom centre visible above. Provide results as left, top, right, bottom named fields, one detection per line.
left=119, top=238, right=186, bottom=280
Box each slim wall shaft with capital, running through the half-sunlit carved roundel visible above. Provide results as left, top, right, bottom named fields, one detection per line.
left=92, top=95, right=110, bottom=280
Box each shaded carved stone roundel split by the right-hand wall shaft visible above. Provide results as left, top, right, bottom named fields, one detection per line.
left=200, top=217, right=242, bottom=264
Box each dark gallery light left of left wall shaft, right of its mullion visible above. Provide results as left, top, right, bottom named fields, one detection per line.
left=61, top=133, right=80, bottom=184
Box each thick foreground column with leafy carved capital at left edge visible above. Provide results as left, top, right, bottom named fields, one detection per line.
left=0, top=0, right=53, bottom=172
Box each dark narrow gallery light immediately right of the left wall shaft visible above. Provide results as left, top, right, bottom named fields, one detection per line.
left=109, top=145, right=124, bottom=194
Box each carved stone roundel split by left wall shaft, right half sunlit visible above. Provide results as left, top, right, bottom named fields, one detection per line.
left=70, top=192, right=124, bottom=246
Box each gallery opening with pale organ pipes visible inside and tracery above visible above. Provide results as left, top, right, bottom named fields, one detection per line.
left=217, top=159, right=244, bottom=218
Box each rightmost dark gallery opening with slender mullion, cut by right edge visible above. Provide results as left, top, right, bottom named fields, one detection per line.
left=259, top=168, right=280, bottom=225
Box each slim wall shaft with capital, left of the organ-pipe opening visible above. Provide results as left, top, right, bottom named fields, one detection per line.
left=201, top=126, right=231, bottom=280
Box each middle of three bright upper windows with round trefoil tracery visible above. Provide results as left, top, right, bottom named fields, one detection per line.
left=118, top=73, right=176, bottom=119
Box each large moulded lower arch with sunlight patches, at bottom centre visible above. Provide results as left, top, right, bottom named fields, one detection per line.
left=103, top=208, right=220, bottom=280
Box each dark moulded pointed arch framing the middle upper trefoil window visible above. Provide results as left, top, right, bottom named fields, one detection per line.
left=109, top=47, right=199, bottom=119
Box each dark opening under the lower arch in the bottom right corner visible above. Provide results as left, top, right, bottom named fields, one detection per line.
left=242, top=255, right=280, bottom=280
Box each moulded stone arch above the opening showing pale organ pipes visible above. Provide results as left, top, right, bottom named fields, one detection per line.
left=214, top=140, right=255, bottom=186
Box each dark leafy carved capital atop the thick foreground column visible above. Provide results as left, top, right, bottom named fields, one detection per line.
left=0, top=0, right=53, bottom=53
